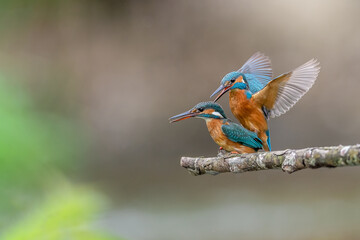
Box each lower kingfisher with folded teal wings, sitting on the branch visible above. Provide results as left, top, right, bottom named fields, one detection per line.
left=169, top=102, right=262, bottom=153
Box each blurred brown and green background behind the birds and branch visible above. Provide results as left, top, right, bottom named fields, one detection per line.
left=0, top=0, right=360, bottom=240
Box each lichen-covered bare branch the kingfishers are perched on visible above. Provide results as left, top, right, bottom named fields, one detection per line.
left=180, top=144, right=360, bottom=175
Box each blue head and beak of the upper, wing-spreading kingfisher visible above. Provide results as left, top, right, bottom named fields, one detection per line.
left=210, top=72, right=249, bottom=102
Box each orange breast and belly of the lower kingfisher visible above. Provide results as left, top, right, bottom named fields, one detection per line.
left=206, top=119, right=255, bottom=153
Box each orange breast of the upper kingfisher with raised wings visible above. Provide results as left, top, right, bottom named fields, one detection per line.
left=229, top=89, right=268, bottom=132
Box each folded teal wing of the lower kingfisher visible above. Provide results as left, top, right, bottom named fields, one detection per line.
left=221, top=122, right=262, bottom=149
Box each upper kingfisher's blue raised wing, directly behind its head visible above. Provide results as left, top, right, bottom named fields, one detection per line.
left=238, top=52, right=272, bottom=93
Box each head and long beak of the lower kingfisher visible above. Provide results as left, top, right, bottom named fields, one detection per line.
left=169, top=102, right=226, bottom=123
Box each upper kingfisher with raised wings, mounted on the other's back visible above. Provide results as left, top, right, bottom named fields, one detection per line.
left=211, top=53, right=320, bottom=151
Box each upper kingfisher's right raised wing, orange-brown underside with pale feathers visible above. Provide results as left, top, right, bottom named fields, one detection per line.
left=253, top=59, right=320, bottom=118
